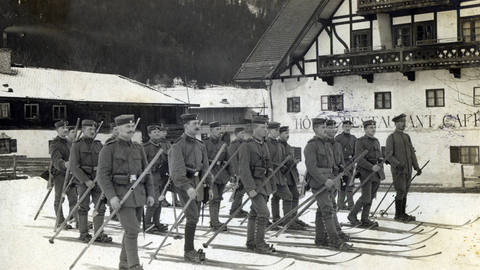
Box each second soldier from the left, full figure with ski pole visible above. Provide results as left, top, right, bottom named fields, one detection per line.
left=70, top=120, right=112, bottom=243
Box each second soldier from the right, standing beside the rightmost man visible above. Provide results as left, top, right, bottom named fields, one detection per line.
left=347, top=120, right=385, bottom=227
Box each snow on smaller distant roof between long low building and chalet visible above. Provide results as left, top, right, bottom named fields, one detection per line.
left=159, top=86, right=269, bottom=108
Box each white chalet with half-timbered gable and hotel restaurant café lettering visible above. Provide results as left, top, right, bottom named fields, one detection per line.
left=235, top=0, right=480, bottom=186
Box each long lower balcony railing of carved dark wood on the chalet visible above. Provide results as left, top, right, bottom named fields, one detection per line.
left=317, top=42, right=480, bottom=77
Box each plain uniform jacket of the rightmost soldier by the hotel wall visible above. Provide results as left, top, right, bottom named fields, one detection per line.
left=385, top=130, right=420, bottom=174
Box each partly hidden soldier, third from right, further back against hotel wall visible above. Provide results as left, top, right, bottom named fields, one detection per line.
left=335, top=120, right=357, bottom=211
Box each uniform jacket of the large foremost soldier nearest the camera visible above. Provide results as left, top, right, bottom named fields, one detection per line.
left=97, top=138, right=155, bottom=207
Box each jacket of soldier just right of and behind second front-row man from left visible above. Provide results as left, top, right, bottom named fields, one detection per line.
left=203, top=137, right=234, bottom=184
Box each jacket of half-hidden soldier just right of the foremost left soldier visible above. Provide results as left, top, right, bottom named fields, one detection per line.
left=143, top=139, right=172, bottom=182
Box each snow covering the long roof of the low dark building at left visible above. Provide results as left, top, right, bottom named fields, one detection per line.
left=0, top=68, right=189, bottom=105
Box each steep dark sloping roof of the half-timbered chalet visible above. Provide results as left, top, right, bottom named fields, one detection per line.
left=234, top=0, right=344, bottom=82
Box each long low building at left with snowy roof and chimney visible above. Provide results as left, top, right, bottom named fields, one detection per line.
left=0, top=49, right=191, bottom=157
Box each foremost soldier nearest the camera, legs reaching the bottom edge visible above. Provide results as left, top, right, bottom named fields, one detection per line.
left=97, top=115, right=155, bottom=270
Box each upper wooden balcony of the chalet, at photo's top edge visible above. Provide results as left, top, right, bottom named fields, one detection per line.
left=357, top=0, right=454, bottom=15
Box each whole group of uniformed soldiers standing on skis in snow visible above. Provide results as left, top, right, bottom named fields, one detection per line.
left=50, top=111, right=421, bottom=269
